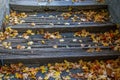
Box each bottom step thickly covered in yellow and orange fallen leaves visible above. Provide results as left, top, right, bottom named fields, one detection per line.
left=0, top=57, right=120, bottom=80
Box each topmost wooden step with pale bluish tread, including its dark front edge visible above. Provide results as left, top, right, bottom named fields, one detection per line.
left=10, top=0, right=107, bottom=11
